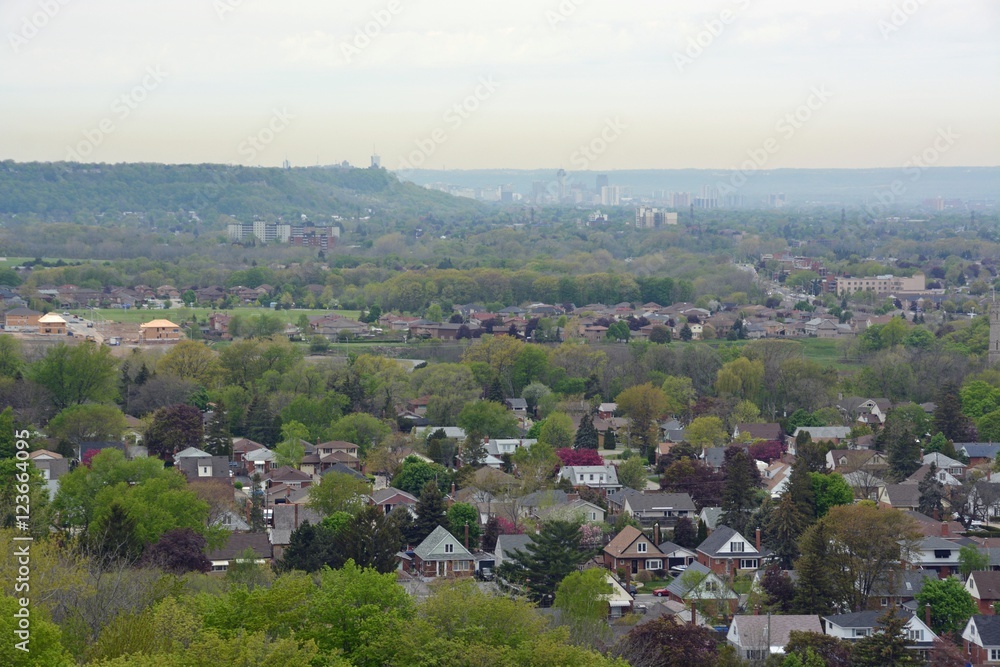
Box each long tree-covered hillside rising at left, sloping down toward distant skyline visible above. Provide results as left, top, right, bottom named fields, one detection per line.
left=0, top=161, right=482, bottom=226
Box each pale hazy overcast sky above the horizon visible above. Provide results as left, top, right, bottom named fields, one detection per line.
left=0, top=0, right=1000, bottom=170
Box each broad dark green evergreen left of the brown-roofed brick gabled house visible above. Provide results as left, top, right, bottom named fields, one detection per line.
left=511, top=520, right=592, bottom=602
